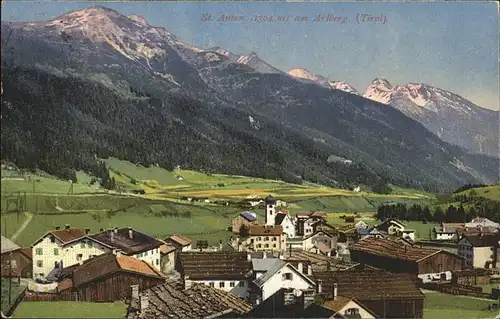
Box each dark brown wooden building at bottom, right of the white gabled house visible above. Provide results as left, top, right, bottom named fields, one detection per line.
left=314, top=269, right=424, bottom=318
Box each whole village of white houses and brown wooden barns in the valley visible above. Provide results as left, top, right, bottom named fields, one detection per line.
left=1, top=196, right=500, bottom=319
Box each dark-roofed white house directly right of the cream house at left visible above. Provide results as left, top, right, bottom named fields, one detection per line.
left=90, top=227, right=164, bottom=270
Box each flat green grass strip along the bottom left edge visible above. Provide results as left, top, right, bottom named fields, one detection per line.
left=12, top=301, right=127, bottom=318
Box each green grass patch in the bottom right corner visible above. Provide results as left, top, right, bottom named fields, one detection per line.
left=424, top=292, right=498, bottom=319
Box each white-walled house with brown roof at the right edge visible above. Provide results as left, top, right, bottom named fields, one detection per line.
left=457, top=233, right=500, bottom=268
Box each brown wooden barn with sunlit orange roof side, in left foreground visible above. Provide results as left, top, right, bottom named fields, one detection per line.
left=57, top=253, right=166, bottom=302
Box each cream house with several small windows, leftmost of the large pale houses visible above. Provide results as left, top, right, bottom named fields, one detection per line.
left=31, top=225, right=114, bottom=279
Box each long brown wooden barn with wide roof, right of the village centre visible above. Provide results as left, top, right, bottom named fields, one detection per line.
left=349, top=236, right=464, bottom=275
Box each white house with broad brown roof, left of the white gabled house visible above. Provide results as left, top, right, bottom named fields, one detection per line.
left=179, top=252, right=252, bottom=298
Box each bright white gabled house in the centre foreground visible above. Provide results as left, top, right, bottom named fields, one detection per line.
left=249, top=256, right=316, bottom=304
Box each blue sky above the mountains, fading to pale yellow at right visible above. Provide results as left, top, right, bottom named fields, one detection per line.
left=2, top=1, right=499, bottom=109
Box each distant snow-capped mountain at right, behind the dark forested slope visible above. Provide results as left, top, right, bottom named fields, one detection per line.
left=363, top=78, right=499, bottom=157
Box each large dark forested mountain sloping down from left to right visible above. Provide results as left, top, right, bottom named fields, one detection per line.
left=2, top=6, right=498, bottom=194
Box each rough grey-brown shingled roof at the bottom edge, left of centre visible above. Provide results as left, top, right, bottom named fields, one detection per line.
left=128, top=283, right=252, bottom=319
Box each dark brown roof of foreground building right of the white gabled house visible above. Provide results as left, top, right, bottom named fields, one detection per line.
left=314, top=269, right=424, bottom=302
